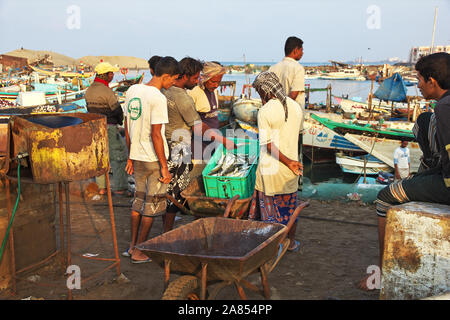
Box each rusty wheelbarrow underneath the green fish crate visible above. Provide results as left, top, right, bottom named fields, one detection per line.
left=166, top=176, right=252, bottom=219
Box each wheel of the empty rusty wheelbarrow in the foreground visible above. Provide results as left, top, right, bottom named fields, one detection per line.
left=162, top=276, right=206, bottom=300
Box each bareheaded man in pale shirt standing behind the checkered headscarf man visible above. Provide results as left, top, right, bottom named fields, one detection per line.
left=269, top=36, right=306, bottom=190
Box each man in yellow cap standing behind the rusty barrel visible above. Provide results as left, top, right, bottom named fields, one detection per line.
left=85, top=62, right=128, bottom=195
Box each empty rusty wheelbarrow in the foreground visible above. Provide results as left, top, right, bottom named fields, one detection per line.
left=137, top=196, right=309, bottom=300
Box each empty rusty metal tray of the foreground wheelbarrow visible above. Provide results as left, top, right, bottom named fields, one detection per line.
left=137, top=217, right=286, bottom=281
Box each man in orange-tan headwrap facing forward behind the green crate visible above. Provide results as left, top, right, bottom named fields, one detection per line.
left=188, top=61, right=226, bottom=179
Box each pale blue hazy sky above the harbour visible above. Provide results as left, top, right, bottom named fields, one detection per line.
left=0, top=0, right=450, bottom=62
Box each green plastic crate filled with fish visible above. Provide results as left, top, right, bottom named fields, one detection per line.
left=202, top=138, right=259, bottom=199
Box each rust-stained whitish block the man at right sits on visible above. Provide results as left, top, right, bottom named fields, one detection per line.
left=380, top=202, right=450, bottom=299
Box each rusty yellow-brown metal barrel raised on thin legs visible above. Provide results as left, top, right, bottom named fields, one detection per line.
left=7, top=113, right=109, bottom=184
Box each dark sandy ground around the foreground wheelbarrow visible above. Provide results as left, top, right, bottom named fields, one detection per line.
left=0, top=180, right=379, bottom=300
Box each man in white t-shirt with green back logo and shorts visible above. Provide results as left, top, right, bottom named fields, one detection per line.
left=123, top=57, right=180, bottom=263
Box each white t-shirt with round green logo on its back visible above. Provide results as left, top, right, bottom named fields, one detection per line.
left=125, top=84, right=169, bottom=162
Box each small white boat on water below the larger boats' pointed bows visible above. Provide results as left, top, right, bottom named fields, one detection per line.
left=336, top=152, right=392, bottom=175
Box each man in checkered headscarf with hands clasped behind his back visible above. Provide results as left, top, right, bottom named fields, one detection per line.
left=249, top=71, right=303, bottom=252
